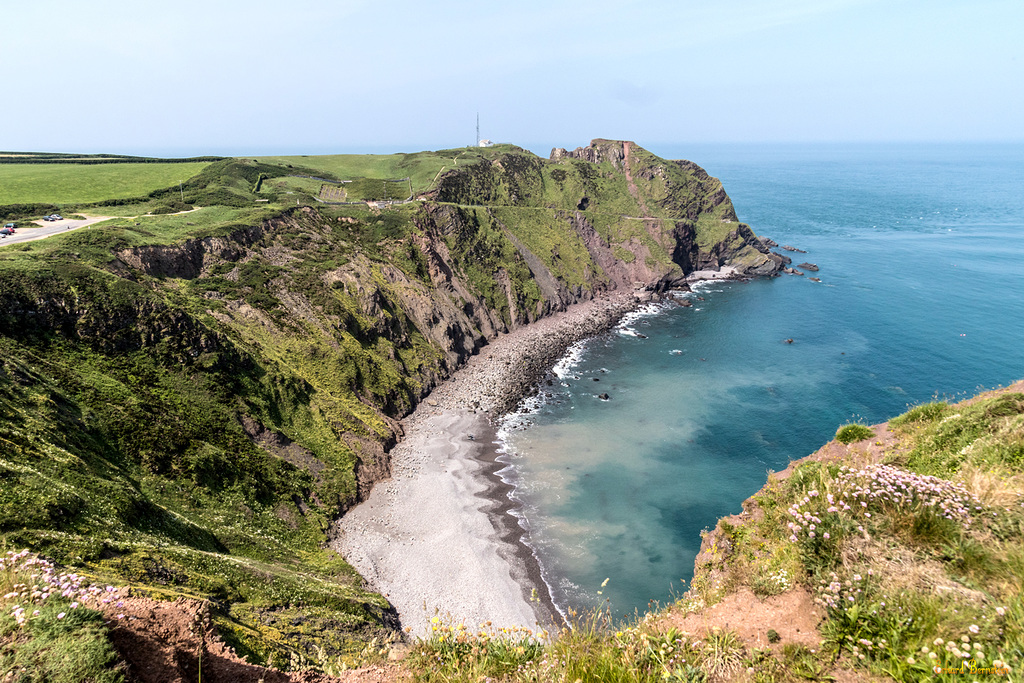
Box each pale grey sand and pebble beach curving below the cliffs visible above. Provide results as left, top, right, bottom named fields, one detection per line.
left=334, top=292, right=649, bottom=636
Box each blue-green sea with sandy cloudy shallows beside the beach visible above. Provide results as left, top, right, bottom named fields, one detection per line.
left=499, top=143, right=1024, bottom=617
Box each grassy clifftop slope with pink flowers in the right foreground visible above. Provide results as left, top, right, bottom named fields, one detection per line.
left=671, top=385, right=1024, bottom=680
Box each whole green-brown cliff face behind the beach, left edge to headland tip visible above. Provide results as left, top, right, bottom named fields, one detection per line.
left=0, top=140, right=778, bottom=659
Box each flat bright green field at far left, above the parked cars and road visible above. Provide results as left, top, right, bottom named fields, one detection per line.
left=0, top=162, right=209, bottom=205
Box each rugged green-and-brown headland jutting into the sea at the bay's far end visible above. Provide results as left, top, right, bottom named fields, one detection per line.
left=428, top=139, right=782, bottom=287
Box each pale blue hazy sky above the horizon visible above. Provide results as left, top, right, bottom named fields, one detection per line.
left=0, top=0, right=1024, bottom=157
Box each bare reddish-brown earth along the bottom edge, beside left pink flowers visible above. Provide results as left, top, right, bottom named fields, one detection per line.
left=97, top=597, right=409, bottom=683
